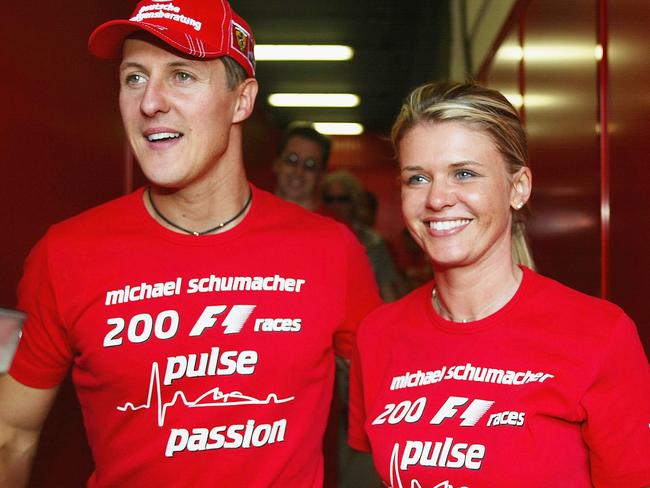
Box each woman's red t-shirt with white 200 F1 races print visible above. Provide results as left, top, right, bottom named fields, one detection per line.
left=350, top=269, right=650, bottom=488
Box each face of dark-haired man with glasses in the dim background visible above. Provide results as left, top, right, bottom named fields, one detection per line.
left=273, top=136, right=324, bottom=202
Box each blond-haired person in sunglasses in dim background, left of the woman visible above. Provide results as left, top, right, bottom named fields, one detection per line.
left=321, top=170, right=405, bottom=302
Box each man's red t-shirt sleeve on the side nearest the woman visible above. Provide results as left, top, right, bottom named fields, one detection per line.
left=334, top=229, right=381, bottom=359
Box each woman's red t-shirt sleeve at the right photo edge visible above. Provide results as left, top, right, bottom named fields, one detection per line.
left=581, top=315, right=650, bottom=488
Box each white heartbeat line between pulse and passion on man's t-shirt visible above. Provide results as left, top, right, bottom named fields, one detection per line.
left=117, top=362, right=296, bottom=427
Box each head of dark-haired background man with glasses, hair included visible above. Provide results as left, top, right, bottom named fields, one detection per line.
left=273, top=124, right=332, bottom=211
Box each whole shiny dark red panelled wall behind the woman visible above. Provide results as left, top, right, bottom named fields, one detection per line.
left=480, top=0, right=650, bottom=348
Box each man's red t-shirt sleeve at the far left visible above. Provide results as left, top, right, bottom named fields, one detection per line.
left=9, top=236, right=72, bottom=388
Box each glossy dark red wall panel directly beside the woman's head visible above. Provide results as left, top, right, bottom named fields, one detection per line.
left=524, top=0, right=600, bottom=295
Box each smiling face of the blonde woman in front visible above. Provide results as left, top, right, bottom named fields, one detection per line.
left=398, top=122, right=531, bottom=270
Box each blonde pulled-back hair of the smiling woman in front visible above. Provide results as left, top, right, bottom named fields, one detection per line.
left=391, top=82, right=535, bottom=268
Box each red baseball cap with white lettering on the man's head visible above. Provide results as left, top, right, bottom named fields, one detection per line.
left=88, top=0, right=255, bottom=78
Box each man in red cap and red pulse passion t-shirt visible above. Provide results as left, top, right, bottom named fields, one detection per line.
left=0, top=0, right=379, bottom=488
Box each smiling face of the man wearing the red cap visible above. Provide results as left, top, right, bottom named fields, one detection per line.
left=120, top=39, right=254, bottom=189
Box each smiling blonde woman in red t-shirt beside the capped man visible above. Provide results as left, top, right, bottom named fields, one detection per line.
left=349, top=83, right=650, bottom=488
